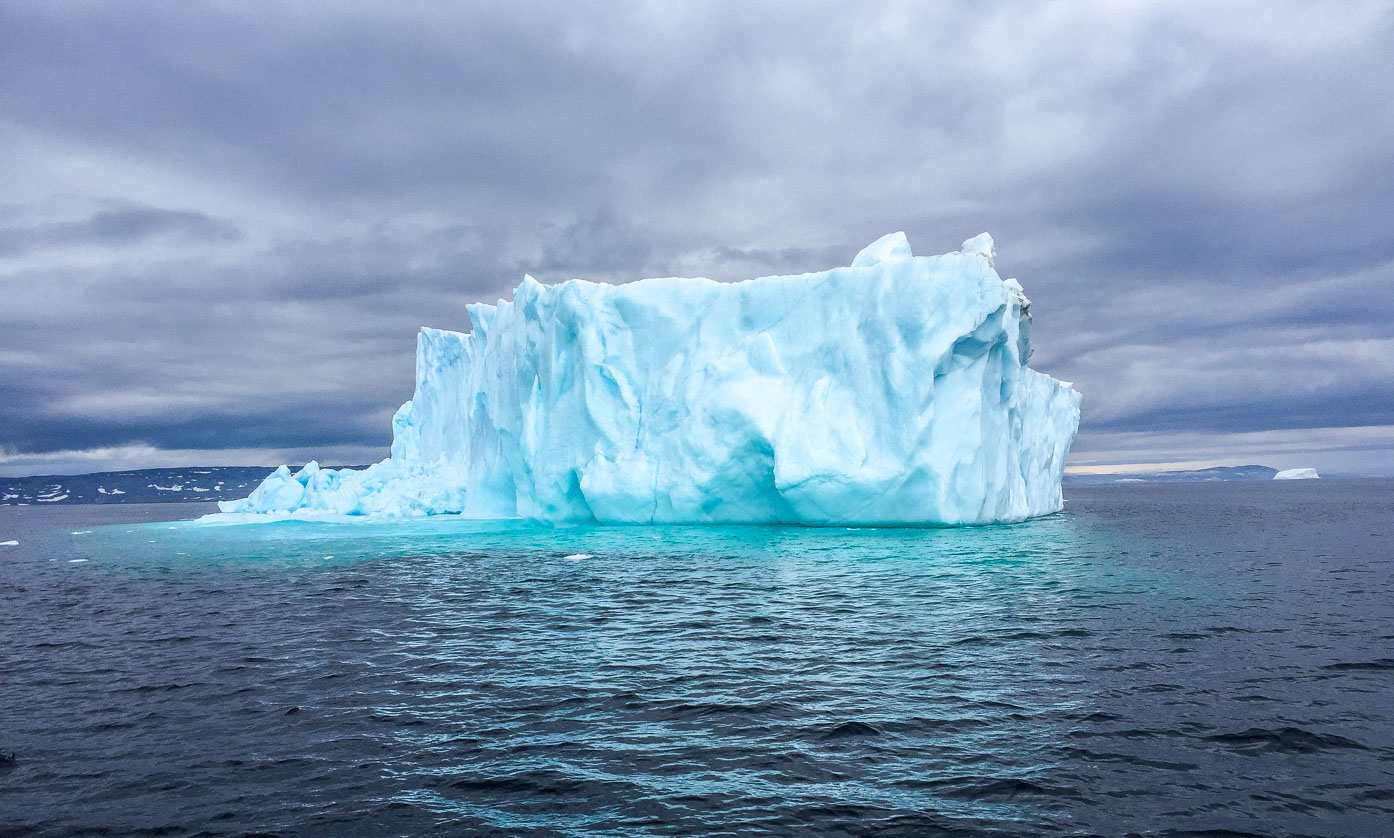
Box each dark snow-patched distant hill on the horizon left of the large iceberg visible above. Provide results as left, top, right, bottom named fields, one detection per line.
left=0, top=466, right=358, bottom=506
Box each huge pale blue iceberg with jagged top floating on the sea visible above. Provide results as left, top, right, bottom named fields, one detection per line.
left=219, top=233, right=1079, bottom=526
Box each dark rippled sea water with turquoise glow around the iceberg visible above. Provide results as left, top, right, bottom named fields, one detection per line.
left=0, top=481, right=1394, bottom=837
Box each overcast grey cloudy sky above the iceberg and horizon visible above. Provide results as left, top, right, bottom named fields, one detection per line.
left=0, top=0, right=1394, bottom=475
